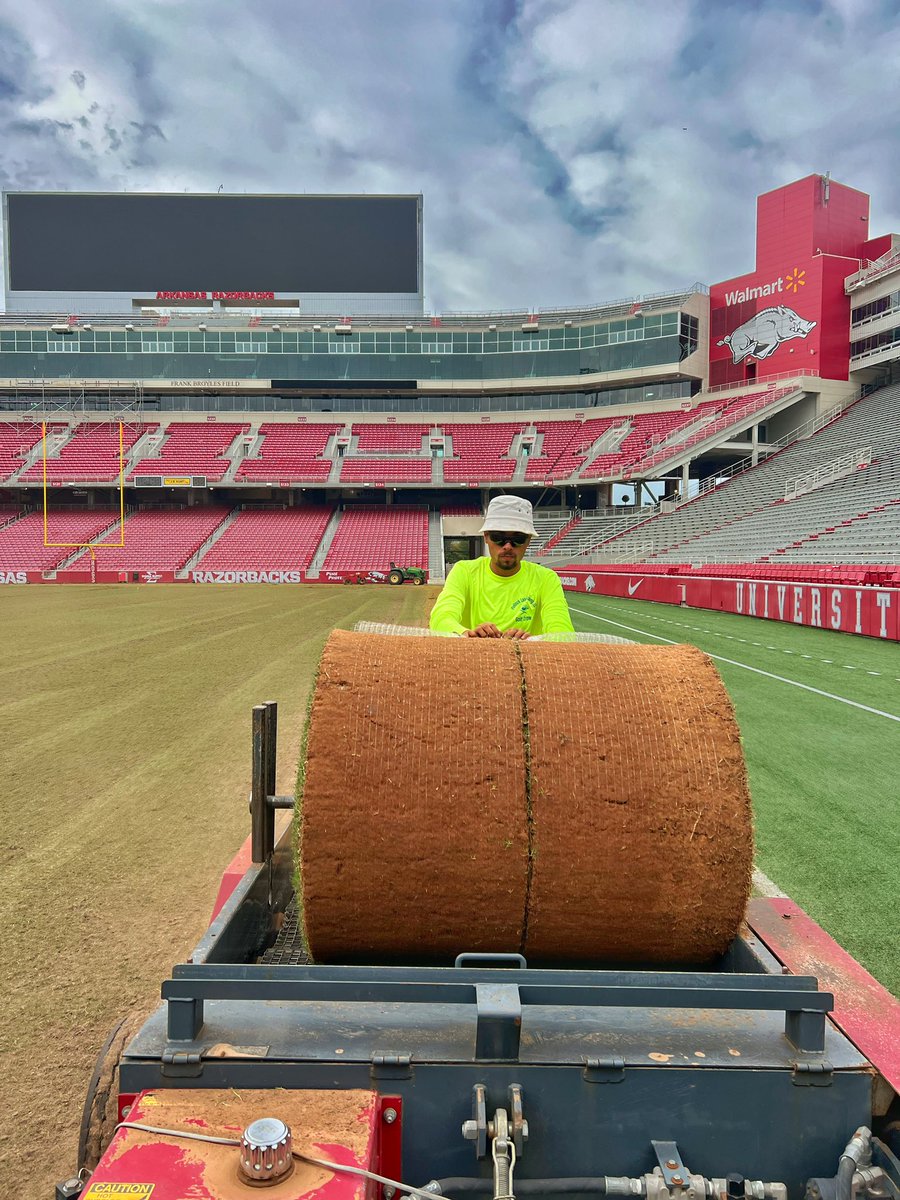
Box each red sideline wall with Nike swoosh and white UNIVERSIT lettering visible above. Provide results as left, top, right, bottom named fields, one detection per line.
left=557, top=568, right=900, bottom=642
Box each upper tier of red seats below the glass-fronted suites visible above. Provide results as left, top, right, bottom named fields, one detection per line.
left=0, top=389, right=806, bottom=486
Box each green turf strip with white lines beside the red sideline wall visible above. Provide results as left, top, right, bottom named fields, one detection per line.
left=569, top=594, right=900, bottom=995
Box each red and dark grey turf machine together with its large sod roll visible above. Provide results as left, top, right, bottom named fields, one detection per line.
left=66, top=628, right=900, bottom=1200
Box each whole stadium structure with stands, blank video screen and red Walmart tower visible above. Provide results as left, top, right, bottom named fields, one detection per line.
left=0, top=175, right=900, bottom=638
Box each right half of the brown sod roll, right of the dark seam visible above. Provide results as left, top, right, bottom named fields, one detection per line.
left=521, top=642, right=752, bottom=962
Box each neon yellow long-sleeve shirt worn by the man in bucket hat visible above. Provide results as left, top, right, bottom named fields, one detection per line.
left=430, top=556, right=574, bottom=634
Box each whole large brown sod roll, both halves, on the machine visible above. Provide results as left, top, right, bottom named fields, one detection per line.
left=299, top=631, right=752, bottom=962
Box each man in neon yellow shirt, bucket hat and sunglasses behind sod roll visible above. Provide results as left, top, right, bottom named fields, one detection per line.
left=430, top=496, right=574, bottom=638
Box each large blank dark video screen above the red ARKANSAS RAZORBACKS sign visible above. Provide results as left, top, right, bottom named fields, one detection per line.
left=6, top=192, right=420, bottom=295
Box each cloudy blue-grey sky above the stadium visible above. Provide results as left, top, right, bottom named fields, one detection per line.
left=0, top=0, right=900, bottom=311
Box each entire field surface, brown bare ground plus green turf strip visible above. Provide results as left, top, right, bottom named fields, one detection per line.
left=0, top=584, right=900, bottom=1195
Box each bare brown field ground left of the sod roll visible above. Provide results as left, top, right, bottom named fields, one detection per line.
left=0, top=584, right=434, bottom=1200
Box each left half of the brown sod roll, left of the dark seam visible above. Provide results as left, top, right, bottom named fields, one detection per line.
left=299, top=631, right=528, bottom=961
